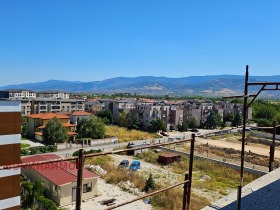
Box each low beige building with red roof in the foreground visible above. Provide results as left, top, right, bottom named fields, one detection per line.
left=21, top=154, right=98, bottom=206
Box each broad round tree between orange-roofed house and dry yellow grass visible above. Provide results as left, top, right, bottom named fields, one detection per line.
left=78, top=116, right=105, bottom=139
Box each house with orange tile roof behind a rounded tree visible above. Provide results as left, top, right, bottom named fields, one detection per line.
left=26, top=113, right=77, bottom=141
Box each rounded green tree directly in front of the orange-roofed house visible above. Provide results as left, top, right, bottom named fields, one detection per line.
left=43, top=117, right=68, bottom=144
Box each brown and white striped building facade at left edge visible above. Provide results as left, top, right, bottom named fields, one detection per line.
left=0, top=100, right=21, bottom=210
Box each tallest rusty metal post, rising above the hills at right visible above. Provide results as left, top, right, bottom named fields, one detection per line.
left=236, top=65, right=249, bottom=210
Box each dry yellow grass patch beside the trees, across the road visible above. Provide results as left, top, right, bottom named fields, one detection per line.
left=106, top=126, right=159, bottom=142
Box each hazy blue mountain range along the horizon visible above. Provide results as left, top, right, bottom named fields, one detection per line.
left=0, top=75, right=280, bottom=97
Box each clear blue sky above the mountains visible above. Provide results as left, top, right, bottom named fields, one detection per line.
left=0, top=0, right=280, bottom=86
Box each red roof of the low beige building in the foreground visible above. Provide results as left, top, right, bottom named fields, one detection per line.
left=21, top=154, right=98, bottom=186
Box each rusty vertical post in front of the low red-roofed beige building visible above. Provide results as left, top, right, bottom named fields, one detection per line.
left=76, top=149, right=85, bottom=210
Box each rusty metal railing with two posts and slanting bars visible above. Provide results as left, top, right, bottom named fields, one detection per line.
left=0, top=134, right=195, bottom=210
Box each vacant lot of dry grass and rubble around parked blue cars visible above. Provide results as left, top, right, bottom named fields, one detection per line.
left=87, top=150, right=257, bottom=210
